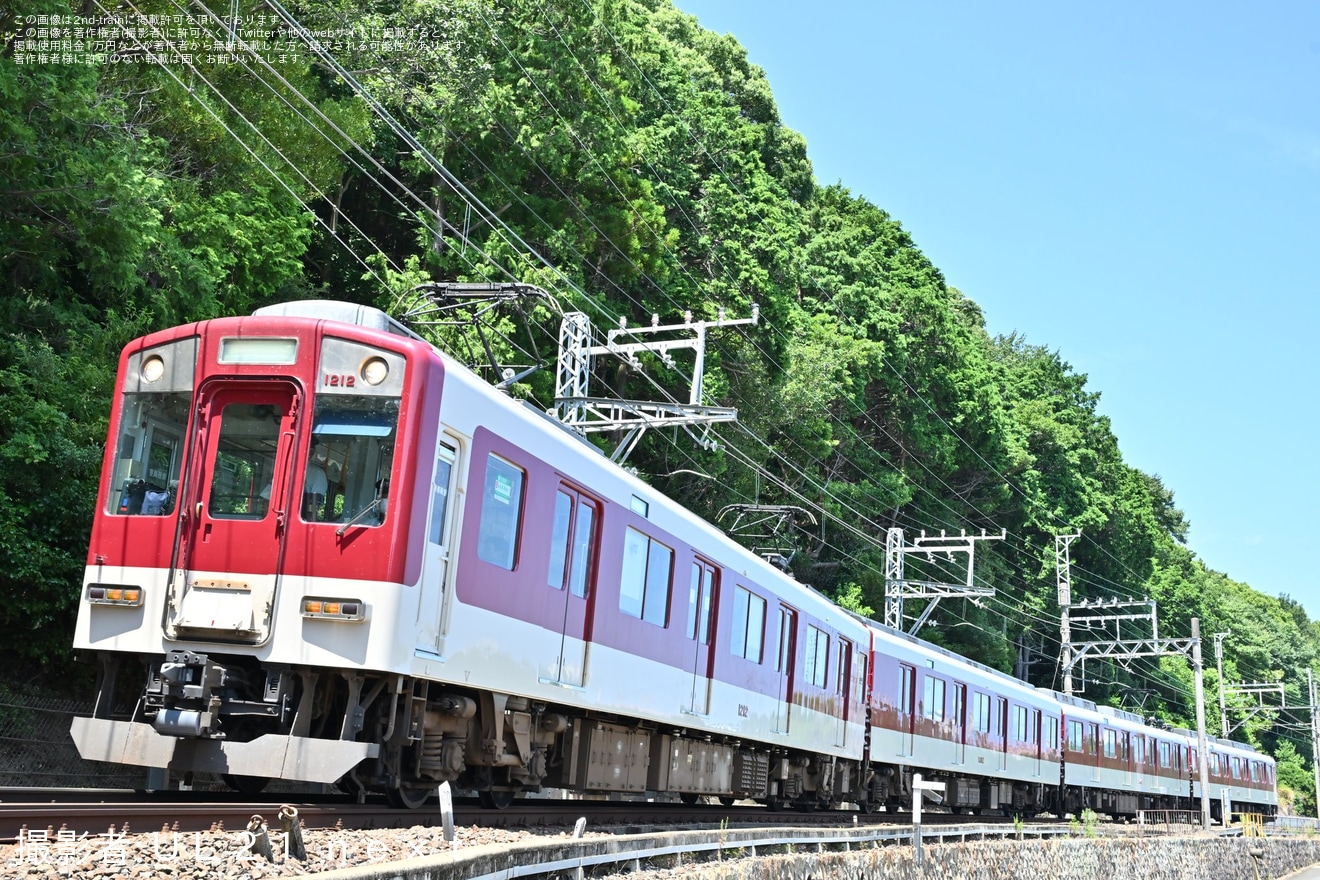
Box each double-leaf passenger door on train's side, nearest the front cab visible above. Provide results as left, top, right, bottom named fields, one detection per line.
left=546, top=483, right=601, bottom=687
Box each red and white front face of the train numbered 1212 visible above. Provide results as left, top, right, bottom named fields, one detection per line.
left=73, top=302, right=442, bottom=788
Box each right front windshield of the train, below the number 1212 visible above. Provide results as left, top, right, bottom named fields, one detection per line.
left=302, top=394, right=399, bottom=526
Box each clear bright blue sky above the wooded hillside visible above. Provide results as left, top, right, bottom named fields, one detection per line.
left=676, top=0, right=1320, bottom=619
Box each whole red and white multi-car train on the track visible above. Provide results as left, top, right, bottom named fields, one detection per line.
left=73, top=301, right=1276, bottom=814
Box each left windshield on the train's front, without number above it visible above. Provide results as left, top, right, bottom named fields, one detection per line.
left=106, top=392, right=193, bottom=516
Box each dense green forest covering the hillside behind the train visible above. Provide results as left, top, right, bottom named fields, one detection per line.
left=0, top=0, right=1320, bottom=805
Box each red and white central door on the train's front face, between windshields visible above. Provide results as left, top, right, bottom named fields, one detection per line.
left=165, top=381, right=302, bottom=644
